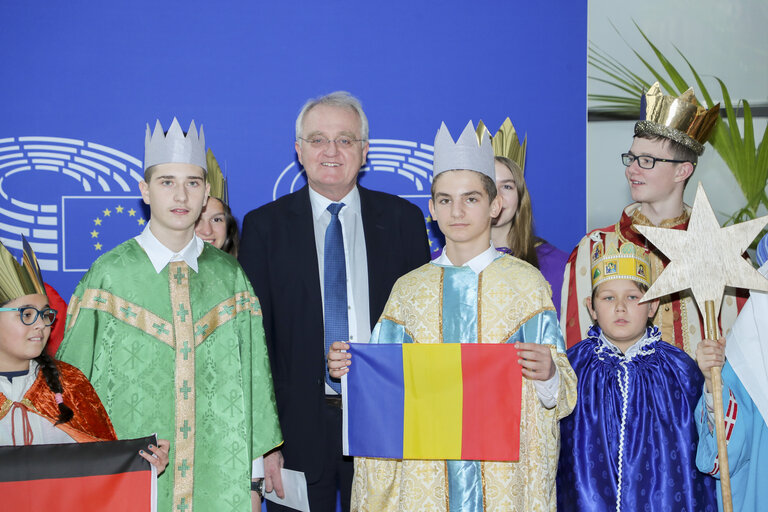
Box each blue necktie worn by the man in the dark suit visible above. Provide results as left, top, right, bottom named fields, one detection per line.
left=323, top=203, right=349, bottom=394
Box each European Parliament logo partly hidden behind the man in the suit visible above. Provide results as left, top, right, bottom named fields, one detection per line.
left=272, top=139, right=443, bottom=255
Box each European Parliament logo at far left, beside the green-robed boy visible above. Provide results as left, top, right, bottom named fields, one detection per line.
left=0, top=137, right=148, bottom=272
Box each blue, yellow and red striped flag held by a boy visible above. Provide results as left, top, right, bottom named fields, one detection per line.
left=342, top=343, right=522, bottom=461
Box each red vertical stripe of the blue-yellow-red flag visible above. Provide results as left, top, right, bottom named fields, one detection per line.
left=461, top=344, right=522, bottom=461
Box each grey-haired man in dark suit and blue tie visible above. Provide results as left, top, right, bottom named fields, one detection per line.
left=239, top=92, right=429, bottom=512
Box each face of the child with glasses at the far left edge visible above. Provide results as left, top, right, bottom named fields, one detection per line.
left=0, top=294, right=51, bottom=372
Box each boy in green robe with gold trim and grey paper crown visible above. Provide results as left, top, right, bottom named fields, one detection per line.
left=57, top=119, right=282, bottom=512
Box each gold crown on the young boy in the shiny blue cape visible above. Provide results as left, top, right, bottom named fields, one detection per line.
left=590, top=233, right=651, bottom=290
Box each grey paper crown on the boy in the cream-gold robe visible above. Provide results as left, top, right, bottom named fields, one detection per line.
left=432, top=121, right=496, bottom=183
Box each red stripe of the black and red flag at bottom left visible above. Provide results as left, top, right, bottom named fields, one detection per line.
left=0, top=471, right=152, bottom=512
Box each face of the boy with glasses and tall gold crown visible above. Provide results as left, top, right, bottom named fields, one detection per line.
left=624, top=137, right=693, bottom=204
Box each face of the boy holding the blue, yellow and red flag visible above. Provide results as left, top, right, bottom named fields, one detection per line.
left=429, top=170, right=501, bottom=254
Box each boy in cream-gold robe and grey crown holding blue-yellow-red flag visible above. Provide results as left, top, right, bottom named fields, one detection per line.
left=328, top=123, right=576, bottom=511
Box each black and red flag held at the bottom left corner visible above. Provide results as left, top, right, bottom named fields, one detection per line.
left=0, top=436, right=157, bottom=512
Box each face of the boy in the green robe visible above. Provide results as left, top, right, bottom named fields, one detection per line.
left=139, top=163, right=210, bottom=246
